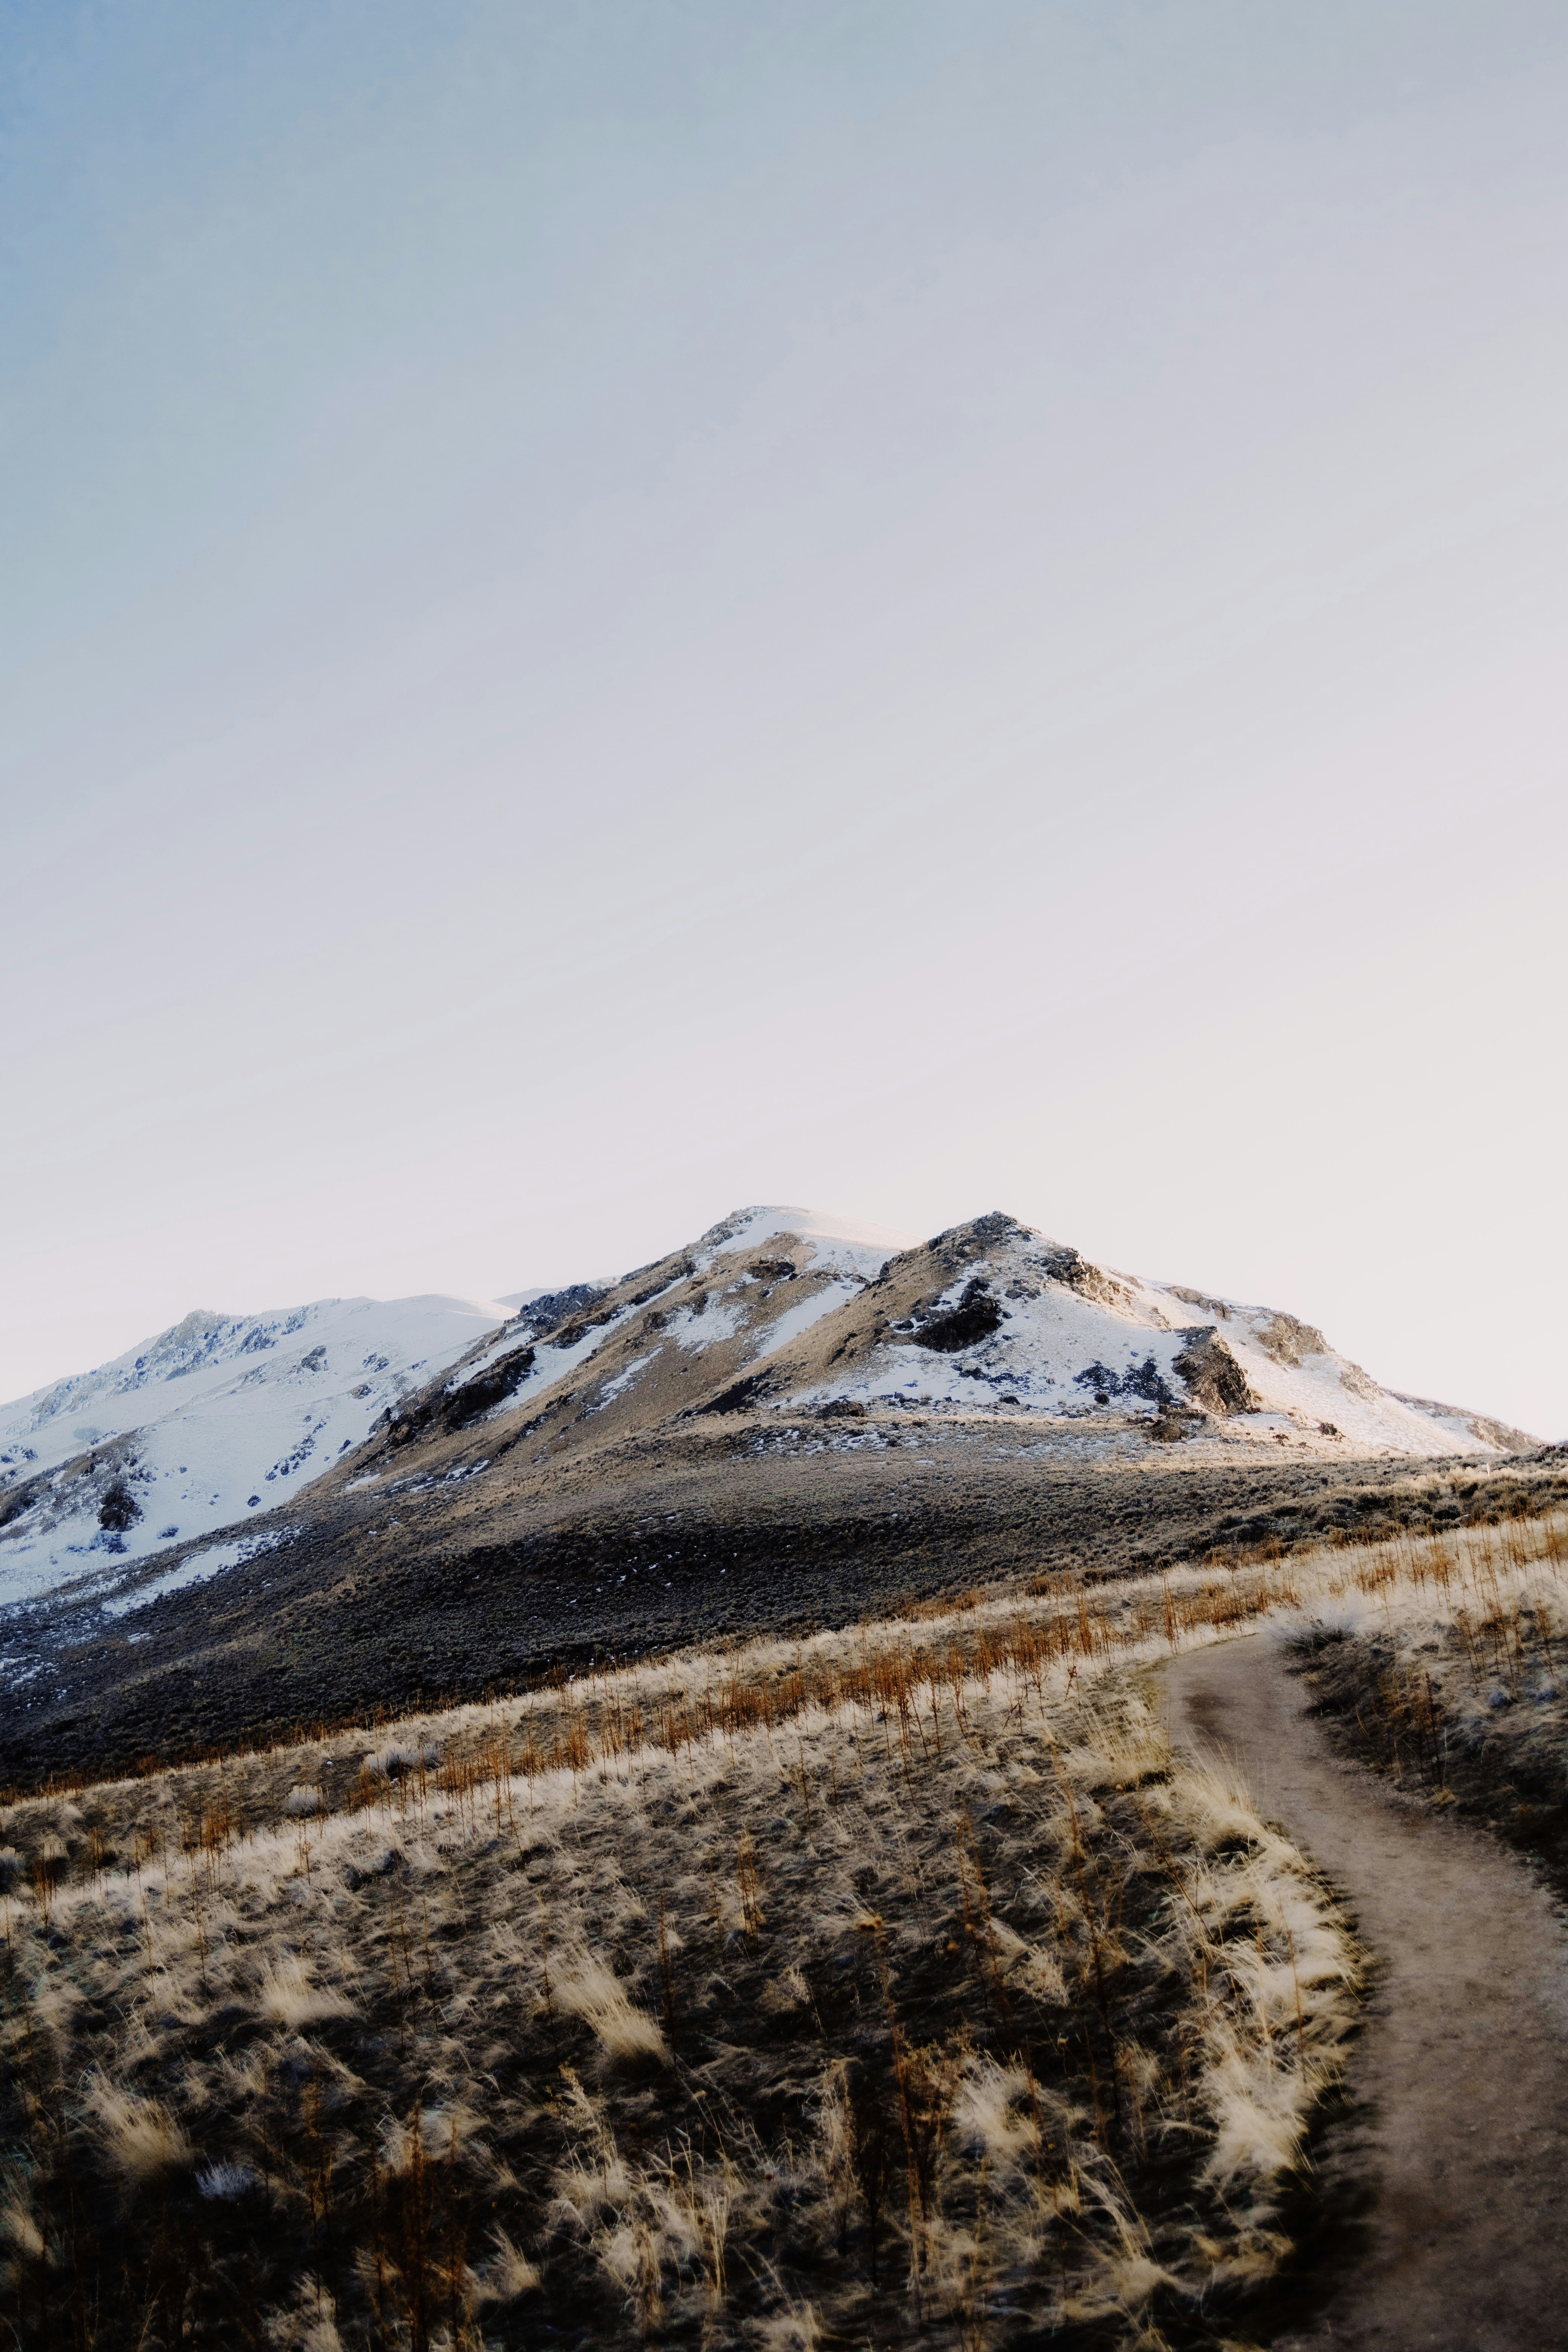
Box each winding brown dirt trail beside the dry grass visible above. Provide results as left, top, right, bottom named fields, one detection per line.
left=1166, top=1637, right=1568, bottom=2352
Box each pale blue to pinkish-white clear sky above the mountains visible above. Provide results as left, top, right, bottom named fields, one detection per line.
left=0, top=0, right=1568, bottom=1437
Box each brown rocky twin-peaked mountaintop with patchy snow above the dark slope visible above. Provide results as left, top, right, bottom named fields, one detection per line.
left=390, top=1209, right=1535, bottom=1458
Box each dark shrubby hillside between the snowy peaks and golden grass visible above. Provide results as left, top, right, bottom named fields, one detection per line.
left=12, top=1413, right=1568, bottom=1787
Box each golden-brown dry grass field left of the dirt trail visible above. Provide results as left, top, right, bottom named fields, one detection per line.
left=15, top=1522, right=1568, bottom=2352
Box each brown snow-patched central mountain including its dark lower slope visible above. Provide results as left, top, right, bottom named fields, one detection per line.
left=0, top=1209, right=1568, bottom=1778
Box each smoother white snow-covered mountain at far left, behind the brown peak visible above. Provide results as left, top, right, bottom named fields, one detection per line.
left=0, top=1296, right=510, bottom=1602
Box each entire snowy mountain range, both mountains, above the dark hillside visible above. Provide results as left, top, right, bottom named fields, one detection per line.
left=0, top=1207, right=1535, bottom=1614
